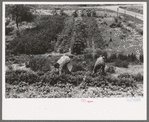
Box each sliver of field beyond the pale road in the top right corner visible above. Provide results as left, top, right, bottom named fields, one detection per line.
left=120, top=6, right=143, bottom=14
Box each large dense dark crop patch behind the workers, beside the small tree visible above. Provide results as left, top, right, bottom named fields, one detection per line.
left=9, top=15, right=65, bottom=54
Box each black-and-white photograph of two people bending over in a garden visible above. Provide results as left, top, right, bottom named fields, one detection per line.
left=3, top=2, right=147, bottom=120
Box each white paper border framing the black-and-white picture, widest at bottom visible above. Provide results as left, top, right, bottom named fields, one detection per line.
left=2, top=2, right=147, bottom=120
